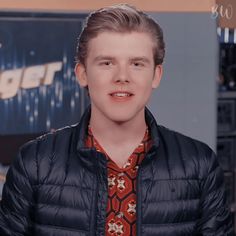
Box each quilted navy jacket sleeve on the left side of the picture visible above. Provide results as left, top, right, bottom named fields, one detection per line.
left=0, top=144, right=33, bottom=236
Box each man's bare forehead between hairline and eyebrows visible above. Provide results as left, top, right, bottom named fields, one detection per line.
left=87, top=32, right=154, bottom=59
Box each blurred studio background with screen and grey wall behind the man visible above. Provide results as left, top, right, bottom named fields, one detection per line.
left=0, top=0, right=236, bottom=232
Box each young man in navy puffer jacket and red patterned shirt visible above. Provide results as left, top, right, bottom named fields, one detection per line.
left=0, top=5, right=233, bottom=236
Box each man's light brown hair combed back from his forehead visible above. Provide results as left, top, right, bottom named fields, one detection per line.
left=76, top=4, right=165, bottom=66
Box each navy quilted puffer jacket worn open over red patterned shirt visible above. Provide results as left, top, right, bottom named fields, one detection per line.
left=0, top=109, right=233, bottom=236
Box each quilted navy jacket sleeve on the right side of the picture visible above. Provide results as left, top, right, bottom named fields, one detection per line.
left=198, top=150, right=234, bottom=236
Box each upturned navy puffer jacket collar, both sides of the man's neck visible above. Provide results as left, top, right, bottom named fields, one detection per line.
left=77, top=105, right=160, bottom=150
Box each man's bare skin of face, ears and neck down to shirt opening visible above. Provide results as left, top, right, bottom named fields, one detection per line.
left=75, top=32, right=162, bottom=166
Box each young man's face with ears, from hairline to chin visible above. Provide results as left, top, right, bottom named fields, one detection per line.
left=75, top=32, right=162, bottom=123
